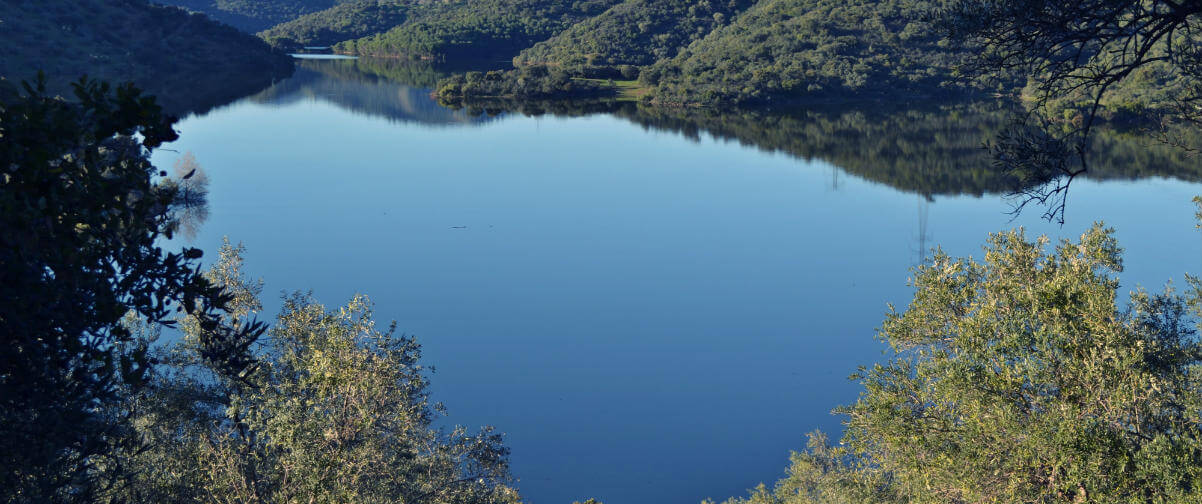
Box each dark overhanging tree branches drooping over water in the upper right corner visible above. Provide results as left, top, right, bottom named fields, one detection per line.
left=933, top=0, right=1202, bottom=223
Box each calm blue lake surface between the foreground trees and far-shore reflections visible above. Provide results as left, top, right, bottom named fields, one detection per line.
left=155, top=62, right=1202, bottom=504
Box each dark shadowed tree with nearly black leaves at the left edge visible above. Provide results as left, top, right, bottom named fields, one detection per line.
left=0, top=78, right=263, bottom=502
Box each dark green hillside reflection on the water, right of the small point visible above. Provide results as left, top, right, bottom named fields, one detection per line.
left=451, top=101, right=1202, bottom=197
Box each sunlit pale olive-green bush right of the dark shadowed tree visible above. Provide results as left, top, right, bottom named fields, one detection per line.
left=113, top=243, right=517, bottom=504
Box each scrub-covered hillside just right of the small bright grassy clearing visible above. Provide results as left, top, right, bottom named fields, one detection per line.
left=642, top=0, right=990, bottom=103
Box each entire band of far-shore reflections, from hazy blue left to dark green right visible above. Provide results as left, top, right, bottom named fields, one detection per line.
left=236, top=59, right=1202, bottom=198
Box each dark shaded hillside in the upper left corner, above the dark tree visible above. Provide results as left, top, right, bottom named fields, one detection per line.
left=0, top=0, right=292, bottom=113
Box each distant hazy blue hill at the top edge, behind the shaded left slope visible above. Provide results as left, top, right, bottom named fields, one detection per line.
left=155, top=0, right=347, bottom=34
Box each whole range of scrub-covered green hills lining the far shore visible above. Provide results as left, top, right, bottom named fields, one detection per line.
left=103, top=0, right=1183, bottom=111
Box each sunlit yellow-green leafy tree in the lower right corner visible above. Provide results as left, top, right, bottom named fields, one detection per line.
left=843, top=226, right=1202, bottom=503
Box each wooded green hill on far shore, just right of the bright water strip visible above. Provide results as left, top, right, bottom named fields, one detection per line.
left=335, top=0, right=618, bottom=60
